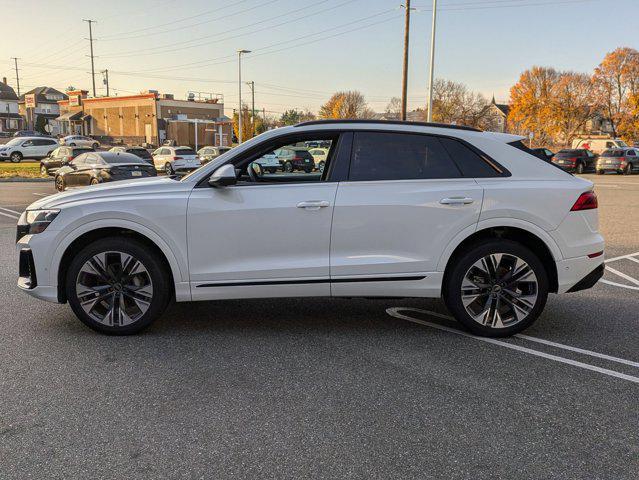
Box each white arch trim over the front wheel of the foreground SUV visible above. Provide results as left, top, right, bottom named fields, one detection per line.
left=50, top=222, right=190, bottom=302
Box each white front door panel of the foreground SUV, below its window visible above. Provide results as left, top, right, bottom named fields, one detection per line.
left=187, top=133, right=350, bottom=300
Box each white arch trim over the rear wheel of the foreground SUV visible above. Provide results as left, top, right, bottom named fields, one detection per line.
left=438, top=220, right=563, bottom=293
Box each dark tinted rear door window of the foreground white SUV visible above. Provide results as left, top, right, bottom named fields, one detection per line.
left=349, top=132, right=461, bottom=181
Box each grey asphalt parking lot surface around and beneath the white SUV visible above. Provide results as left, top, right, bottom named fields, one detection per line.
left=0, top=175, right=639, bottom=479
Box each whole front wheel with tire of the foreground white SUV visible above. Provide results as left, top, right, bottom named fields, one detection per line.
left=66, top=238, right=172, bottom=335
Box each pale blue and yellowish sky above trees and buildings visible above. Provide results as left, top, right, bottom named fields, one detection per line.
left=0, top=0, right=639, bottom=116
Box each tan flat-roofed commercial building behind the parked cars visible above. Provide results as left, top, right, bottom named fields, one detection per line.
left=57, top=90, right=231, bottom=146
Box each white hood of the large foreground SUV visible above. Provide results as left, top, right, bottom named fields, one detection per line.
left=27, top=177, right=193, bottom=210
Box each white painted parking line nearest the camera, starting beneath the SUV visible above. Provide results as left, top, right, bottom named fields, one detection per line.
left=386, top=307, right=639, bottom=384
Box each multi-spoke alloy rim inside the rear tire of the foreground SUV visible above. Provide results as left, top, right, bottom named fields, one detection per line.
left=461, top=253, right=539, bottom=328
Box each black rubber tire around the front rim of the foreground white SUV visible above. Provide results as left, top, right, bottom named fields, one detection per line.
left=65, top=237, right=173, bottom=335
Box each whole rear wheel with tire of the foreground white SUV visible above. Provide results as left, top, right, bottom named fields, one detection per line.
left=443, top=239, right=548, bottom=337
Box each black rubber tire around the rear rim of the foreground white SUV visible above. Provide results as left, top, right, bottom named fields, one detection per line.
left=443, top=239, right=548, bottom=337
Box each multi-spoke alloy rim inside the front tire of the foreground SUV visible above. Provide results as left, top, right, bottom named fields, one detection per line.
left=75, top=251, right=153, bottom=327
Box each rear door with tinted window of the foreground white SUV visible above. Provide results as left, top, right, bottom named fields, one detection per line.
left=330, top=132, right=483, bottom=296
